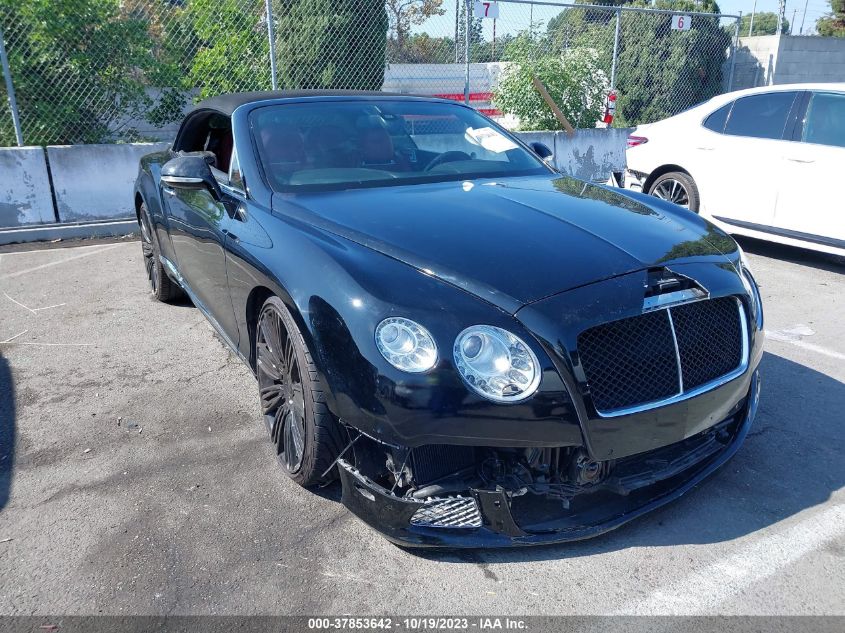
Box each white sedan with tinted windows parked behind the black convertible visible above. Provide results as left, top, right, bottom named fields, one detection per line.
left=624, top=83, right=845, bottom=256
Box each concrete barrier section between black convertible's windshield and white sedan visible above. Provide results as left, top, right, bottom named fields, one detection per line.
left=518, top=128, right=631, bottom=182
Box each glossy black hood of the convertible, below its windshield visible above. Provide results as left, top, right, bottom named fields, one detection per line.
left=273, top=176, right=736, bottom=313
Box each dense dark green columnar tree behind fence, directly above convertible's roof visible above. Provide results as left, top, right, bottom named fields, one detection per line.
left=274, top=0, right=388, bottom=90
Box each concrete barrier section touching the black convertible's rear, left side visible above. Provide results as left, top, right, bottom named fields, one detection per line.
left=47, top=143, right=168, bottom=222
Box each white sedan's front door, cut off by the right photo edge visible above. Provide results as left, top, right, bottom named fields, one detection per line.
left=773, top=91, right=845, bottom=248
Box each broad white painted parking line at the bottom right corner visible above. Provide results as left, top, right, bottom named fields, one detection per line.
left=624, top=504, right=845, bottom=615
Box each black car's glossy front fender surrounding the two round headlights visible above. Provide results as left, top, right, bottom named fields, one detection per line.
left=228, top=205, right=582, bottom=446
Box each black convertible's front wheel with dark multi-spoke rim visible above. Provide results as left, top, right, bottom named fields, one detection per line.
left=255, top=297, right=343, bottom=487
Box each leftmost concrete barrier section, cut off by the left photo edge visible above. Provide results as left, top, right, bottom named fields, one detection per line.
left=0, top=147, right=56, bottom=227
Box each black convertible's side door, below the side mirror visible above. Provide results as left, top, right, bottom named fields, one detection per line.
left=162, top=131, right=243, bottom=345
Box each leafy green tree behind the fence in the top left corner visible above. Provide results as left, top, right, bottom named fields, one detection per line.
left=0, top=0, right=178, bottom=145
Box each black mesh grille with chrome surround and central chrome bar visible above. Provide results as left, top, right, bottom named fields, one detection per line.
left=578, top=297, right=747, bottom=415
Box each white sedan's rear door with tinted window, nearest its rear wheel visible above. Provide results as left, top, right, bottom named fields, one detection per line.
left=699, top=91, right=799, bottom=225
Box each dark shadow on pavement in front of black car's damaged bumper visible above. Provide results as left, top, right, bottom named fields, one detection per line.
left=409, top=353, right=845, bottom=564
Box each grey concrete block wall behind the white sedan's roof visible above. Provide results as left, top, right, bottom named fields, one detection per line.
left=725, top=35, right=845, bottom=90
